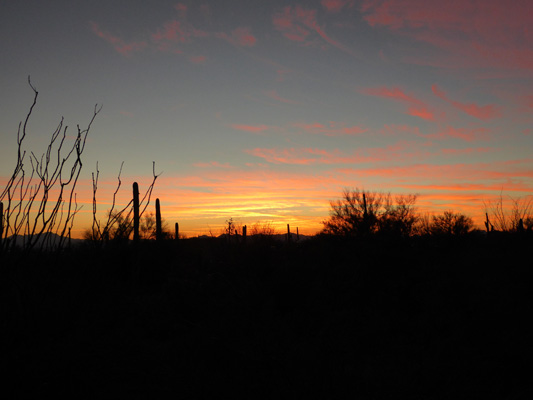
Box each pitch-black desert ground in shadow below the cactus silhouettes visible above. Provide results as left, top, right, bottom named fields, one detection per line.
left=0, top=238, right=533, bottom=399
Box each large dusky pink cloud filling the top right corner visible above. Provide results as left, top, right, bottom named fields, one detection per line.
left=361, top=0, right=533, bottom=70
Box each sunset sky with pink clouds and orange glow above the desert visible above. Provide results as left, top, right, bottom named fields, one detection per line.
left=0, top=0, right=533, bottom=237
